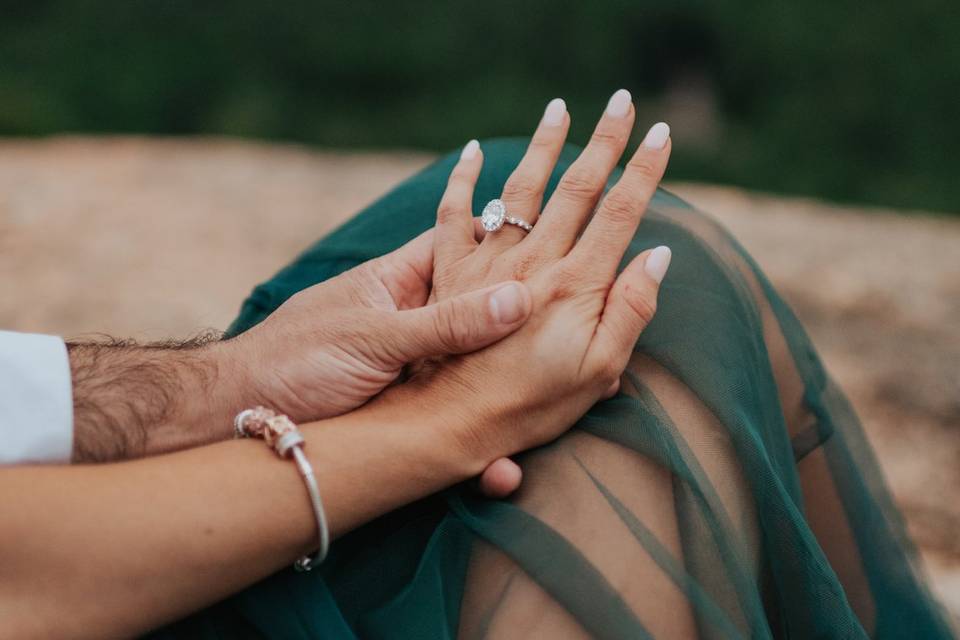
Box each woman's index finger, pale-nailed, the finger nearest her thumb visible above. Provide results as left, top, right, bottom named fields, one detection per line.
left=570, top=122, right=670, bottom=282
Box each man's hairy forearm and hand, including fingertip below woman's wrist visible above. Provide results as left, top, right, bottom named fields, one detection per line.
left=68, top=231, right=531, bottom=497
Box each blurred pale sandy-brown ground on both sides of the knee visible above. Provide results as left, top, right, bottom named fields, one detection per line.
left=0, top=138, right=960, bottom=619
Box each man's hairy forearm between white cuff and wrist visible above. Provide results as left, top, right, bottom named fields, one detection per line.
left=67, top=338, right=239, bottom=462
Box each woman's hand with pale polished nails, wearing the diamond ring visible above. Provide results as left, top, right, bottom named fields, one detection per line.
left=389, top=90, right=670, bottom=471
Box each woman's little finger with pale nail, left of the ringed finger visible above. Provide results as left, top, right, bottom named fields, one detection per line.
left=435, top=140, right=483, bottom=266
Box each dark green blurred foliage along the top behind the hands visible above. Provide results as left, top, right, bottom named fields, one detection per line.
left=0, top=0, right=960, bottom=212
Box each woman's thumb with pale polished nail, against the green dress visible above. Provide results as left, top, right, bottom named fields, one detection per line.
left=591, top=247, right=672, bottom=375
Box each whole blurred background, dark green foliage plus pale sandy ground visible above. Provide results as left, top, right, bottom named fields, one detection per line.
left=0, top=0, right=960, bottom=616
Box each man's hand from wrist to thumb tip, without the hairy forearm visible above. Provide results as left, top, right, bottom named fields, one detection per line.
left=222, top=230, right=531, bottom=422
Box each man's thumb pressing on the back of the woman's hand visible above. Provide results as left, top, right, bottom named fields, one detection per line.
left=396, top=282, right=533, bottom=362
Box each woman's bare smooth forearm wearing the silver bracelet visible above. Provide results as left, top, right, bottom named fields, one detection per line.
left=0, top=403, right=483, bottom=638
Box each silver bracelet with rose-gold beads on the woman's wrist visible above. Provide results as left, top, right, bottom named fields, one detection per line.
left=233, top=407, right=330, bottom=571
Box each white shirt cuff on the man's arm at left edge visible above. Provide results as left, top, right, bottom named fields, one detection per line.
left=0, top=331, right=73, bottom=464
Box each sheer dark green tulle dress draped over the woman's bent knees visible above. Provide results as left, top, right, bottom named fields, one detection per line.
left=148, top=140, right=950, bottom=639
